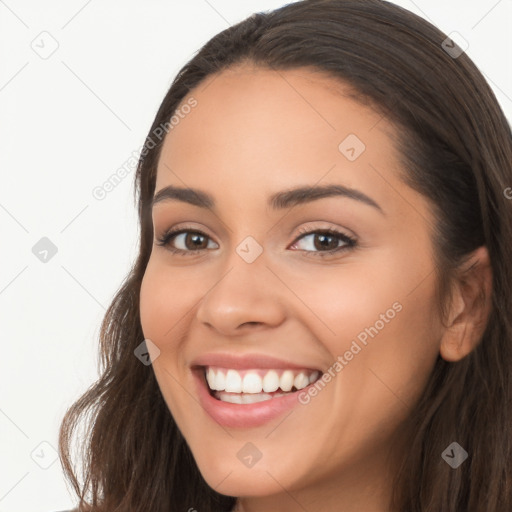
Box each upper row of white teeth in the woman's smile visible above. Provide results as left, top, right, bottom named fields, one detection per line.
left=206, top=367, right=320, bottom=394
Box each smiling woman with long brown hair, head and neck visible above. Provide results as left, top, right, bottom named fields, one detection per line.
left=60, top=0, right=512, bottom=512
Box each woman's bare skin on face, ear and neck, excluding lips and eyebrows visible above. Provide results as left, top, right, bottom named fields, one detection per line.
left=140, top=65, right=491, bottom=512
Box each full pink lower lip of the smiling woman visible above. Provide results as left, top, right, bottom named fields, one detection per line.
left=192, top=370, right=313, bottom=428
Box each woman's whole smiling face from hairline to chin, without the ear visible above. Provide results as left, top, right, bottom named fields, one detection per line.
left=140, top=66, right=441, bottom=508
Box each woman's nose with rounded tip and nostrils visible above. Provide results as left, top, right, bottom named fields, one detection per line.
left=196, top=260, right=285, bottom=336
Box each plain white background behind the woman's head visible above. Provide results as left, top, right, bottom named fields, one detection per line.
left=0, top=0, right=512, bottom=512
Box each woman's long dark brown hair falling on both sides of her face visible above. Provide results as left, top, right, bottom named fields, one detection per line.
left=59, top=0, right=512, bottom=512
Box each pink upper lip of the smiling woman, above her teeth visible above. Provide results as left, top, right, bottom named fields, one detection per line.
left=191, top=352, right=320, bottom=371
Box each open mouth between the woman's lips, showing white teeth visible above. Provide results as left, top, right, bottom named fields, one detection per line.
left=201, top=366, right=321, bottom=404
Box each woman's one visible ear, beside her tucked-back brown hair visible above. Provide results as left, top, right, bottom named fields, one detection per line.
left=439, top=246, right=492, bottom=362
